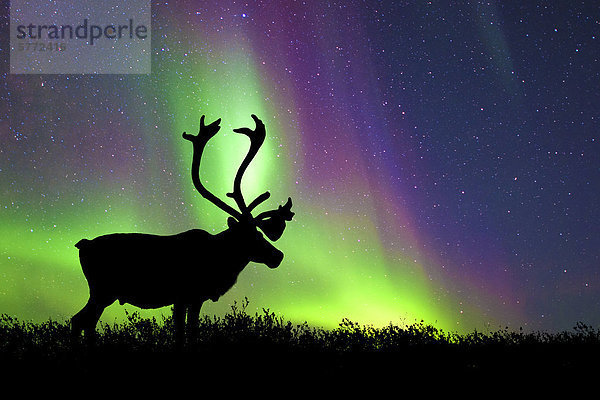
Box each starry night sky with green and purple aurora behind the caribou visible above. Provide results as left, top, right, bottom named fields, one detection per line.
left=0, top=1, right=600, bottom=331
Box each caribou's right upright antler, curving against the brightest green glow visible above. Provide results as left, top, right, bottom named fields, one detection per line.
left=227, top=114, right=271, bottom=218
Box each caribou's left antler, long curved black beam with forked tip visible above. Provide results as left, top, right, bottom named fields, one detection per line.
left=183, top=115, right=241, bottom=221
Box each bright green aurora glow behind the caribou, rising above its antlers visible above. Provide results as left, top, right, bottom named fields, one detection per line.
left=0, top=35, right=510, bottom=331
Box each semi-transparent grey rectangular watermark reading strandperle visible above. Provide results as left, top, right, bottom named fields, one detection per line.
left=10, top=0, right=151, bottom=74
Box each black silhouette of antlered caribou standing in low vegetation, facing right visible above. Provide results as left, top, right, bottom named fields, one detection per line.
left=71, top=114, right=294, bottom=344
